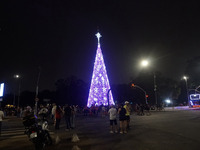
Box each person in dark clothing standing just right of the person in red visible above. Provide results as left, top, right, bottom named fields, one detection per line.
left=64, top=104, right=72, bottom=131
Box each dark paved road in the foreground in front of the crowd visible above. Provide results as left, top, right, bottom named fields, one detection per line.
left=0, top=109, right=200, bottom=150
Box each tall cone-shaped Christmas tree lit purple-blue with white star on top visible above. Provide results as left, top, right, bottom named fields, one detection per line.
left=87, top=32, right=115, bottom=107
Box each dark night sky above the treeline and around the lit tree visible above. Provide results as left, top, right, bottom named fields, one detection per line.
left=0, top=0, right=200, bottom=90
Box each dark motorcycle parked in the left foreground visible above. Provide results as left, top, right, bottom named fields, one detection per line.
left=23, top=115, right=52, bottom=150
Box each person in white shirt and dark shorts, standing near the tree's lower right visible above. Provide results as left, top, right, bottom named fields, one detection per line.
left=108, top=105, right=117, bottom=133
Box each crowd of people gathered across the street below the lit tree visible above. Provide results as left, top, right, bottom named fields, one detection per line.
left=0, top=101, right=156, bottom=137
